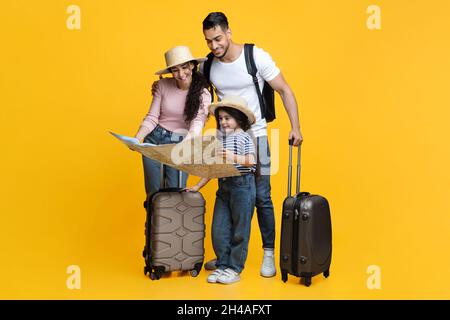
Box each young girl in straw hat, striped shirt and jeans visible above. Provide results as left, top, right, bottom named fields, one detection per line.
left=187, top=96, right=256, bottom=284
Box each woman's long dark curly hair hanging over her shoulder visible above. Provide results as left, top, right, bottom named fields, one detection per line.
left=184, top=61, right=209, bottom=125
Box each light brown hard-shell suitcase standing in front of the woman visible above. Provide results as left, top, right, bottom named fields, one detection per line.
left=143, top=165, right=205, bottom=280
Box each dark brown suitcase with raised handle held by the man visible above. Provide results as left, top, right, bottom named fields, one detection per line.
left=280, top=140, right=332, bottom=287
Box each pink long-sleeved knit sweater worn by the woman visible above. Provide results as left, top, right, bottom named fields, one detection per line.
left=139, top=78, right=211, bottom=137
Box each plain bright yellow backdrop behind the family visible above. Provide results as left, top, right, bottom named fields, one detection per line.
left=0, top=0, right=450, bottom=299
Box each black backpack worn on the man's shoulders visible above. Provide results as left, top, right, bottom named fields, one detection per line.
left=203, top=43, right=276, bottom=122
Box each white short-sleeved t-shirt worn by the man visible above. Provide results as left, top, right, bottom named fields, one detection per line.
left=200, top=46, right=280, bottom=137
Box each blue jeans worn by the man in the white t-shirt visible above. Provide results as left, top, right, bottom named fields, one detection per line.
left=256, top=136, right=275, bottom=249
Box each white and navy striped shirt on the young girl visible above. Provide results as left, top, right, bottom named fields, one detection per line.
left=218, top=130, right=256, bottom=175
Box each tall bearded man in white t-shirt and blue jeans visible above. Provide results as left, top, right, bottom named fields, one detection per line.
left=201, top=12, right=303, bottom=277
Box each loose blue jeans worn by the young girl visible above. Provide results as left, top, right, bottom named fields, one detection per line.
left=211, top=173, right=256, bottom=273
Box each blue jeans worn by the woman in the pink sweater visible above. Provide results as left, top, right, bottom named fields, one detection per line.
left=142, top=125, right=188, bottom=195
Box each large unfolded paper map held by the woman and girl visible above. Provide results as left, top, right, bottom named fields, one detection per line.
left=110, top=132, right=240, bottom=179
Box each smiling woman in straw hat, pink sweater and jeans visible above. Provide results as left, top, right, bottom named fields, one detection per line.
left=135, top=46, right=211, bottom=194
